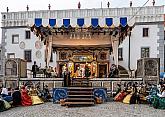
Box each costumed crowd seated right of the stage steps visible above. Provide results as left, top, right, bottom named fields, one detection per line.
left=114, top=82, right=165, bottom=109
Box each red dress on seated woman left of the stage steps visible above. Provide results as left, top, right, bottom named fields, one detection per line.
left=21, top=89, right=32, bottom=106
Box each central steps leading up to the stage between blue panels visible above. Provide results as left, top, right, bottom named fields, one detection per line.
left=64, top=87, right=95, bottom=106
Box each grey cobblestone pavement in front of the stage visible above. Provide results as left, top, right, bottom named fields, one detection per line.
left=0, top=102, right=165, bottom=117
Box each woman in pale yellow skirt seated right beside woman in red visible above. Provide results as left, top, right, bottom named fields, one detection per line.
left=29, top=86, right=44, bottom=105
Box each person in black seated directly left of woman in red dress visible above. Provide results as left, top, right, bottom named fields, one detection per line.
left=12, top=87, right=21, bottom=106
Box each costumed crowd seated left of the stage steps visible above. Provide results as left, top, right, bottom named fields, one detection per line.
left=0, top=85, right=51, bottom=112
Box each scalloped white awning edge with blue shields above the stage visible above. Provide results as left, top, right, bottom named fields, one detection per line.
left=29, top=17, right=131, bottom=28
